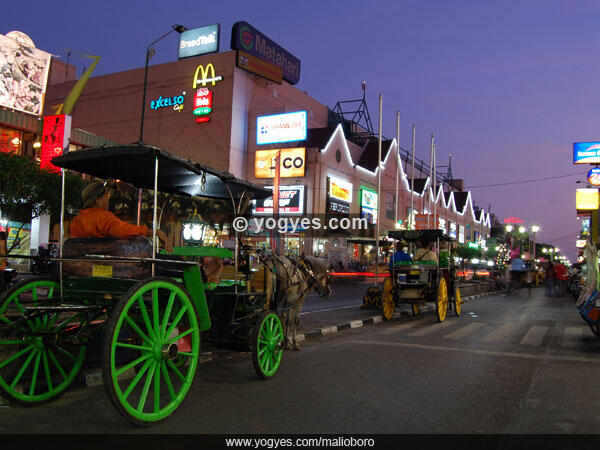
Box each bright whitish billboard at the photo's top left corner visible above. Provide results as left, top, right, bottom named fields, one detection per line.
left=0, top=32, right=52, bottom=116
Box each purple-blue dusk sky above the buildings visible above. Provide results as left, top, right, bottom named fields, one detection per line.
left=0, top=0, right=600, bottom=258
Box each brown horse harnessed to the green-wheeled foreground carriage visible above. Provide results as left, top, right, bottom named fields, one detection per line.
left=263, top=256, right=331, bottom=350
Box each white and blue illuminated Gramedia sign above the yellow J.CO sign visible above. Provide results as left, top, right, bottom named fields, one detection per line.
left=256, top=111, right=306, bottom=144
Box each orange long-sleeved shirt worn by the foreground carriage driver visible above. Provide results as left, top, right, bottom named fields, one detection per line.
left=70, top=208, right=148, bottom=239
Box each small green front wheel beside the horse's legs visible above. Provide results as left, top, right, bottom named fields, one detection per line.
left=252, top=311, right=284, bottom=380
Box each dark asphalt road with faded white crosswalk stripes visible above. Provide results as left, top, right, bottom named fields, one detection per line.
left=0, top=289, right=600, bottom=434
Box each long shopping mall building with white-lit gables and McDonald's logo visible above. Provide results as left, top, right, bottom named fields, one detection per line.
left=0, top=24, right=490, bottom=264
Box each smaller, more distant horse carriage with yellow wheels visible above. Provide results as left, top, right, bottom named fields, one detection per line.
left=381, top=230, right=461, bottom=322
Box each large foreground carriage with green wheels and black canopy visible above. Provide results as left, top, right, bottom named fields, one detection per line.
left=0, top=145, right=328, bottom=426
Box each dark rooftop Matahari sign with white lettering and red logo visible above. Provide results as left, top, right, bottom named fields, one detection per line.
left=231, top=22, right=300, bottom=84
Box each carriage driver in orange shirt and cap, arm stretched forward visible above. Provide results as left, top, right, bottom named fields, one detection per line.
left=70, top=181, right=171, bottom=252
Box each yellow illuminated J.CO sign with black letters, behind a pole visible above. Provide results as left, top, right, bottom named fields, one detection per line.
left=254, top=147, right=306, bottom=178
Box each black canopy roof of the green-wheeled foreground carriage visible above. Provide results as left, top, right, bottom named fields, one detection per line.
left=52, top=144, right=273, bottom=199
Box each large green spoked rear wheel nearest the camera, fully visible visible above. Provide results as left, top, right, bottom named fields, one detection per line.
left=102, top=277, right=200, bottom=426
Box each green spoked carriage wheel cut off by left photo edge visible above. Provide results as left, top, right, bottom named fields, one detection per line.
left=0, top=278, right=87, bottom=406
